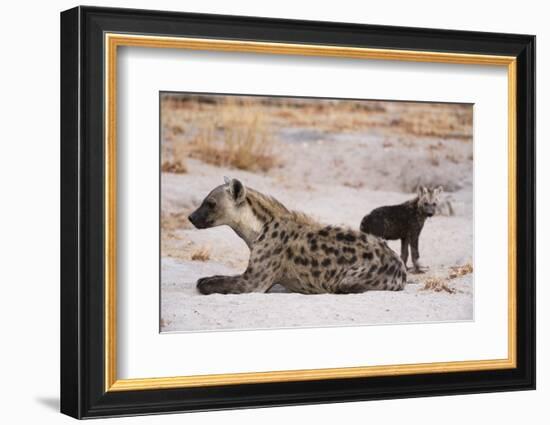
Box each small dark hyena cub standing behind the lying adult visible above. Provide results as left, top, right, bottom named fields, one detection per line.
left=360, top=186, right=442, bottom=273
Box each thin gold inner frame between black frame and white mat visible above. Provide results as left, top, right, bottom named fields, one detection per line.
left=104, top=33, right=517, bottom=391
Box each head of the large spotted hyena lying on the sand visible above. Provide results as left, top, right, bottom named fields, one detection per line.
left=188, top=177, right=258, bottom=229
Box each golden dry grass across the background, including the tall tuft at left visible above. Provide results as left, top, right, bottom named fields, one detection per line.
left=161, top=95, right=472, bottom=177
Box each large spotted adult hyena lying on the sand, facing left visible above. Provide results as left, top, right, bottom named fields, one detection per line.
left=189, top=179, right=406, bottom=294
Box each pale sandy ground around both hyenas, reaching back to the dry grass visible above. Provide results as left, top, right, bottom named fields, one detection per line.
left=161, top=110, right=473, bottom=332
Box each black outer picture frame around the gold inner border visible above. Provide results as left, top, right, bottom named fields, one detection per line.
left=61, top=7, right=535, bottom=418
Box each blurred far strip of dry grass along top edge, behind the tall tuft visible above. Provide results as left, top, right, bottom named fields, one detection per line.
left=162, top=95, right=472, bottom=139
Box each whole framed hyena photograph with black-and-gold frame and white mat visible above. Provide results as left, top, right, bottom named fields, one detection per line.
left=61, top=7, right=535, bottom=418
